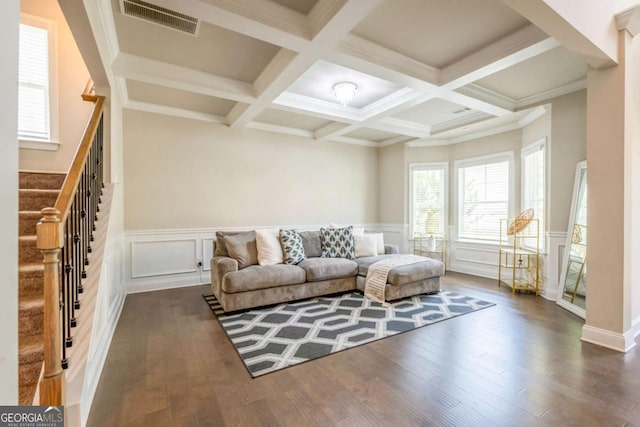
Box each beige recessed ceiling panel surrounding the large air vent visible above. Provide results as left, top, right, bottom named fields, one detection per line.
left=112, top=0, right=279, bottom=83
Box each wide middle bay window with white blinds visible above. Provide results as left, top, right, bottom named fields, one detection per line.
left=456, top=153, right=513, bottom=242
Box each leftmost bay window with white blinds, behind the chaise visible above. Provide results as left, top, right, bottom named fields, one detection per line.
left=410, top=163, right=448, bottom=235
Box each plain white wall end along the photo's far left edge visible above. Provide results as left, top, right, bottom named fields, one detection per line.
left=0, top=0, right=20, bottom=405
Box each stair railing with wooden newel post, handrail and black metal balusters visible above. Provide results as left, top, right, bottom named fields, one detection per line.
left=37, top=95, right=104, bottom=406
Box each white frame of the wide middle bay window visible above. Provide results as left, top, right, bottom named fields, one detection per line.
left=453, top=151, right=516, bottom=245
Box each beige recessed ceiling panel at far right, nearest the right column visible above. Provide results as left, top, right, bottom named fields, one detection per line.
left=475, top=46, right=587, bottom=100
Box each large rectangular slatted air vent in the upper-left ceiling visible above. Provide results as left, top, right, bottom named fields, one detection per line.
left=120, top=0, right=199, bottom=36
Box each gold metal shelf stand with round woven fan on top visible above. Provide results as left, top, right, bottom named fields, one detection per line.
left=498, top=209, right=540, bottom=295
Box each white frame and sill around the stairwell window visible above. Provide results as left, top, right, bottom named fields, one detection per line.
left=18, top=13, right=60, bottom=151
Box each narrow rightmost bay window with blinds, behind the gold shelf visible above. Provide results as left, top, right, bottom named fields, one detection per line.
left=521, top=141, right=546, bottom=248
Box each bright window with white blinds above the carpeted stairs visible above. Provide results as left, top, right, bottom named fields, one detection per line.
left=18, top=18, right=51, bottom=141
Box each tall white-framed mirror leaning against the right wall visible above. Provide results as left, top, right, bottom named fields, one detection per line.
left=557, top=161, right=587, bottom=318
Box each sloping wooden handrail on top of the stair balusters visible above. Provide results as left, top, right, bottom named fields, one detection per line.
left=55, top=96, right=104, bottom=223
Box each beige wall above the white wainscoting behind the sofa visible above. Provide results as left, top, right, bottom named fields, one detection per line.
left=124, top=110, right=378, bottom=230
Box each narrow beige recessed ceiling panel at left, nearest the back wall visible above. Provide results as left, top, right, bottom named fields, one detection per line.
left=127, top=80, right=235, bottom=116
